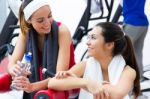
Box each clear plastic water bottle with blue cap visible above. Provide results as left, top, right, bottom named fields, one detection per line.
left=11, top=52, right=32, bottom=89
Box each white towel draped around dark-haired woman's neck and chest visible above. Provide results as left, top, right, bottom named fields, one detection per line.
left=79, top=55, right=130, bottom=99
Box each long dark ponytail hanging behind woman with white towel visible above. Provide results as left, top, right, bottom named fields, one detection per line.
left=122, top=35, right=140, bottom=97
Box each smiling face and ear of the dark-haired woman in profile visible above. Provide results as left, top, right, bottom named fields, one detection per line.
left=87, top=26, right=112, bottom=57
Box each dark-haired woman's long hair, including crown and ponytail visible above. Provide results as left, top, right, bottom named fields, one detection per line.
left=96, top=22, right=140, bottom=97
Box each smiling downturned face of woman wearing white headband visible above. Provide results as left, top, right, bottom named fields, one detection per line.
left=29, top=5, right=53, bottom=34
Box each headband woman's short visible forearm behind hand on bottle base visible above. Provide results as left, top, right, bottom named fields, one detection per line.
left=31, top=78, right=49, bottom=92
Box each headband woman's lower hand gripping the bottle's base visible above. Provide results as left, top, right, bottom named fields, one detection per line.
left=12, top=76, right=33, bottom=93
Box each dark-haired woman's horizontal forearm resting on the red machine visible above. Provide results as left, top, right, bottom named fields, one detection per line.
left=48, top=77, right=87, bottom=90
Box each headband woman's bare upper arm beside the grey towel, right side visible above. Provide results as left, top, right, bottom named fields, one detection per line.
left=56, top=24, right=71, bottom=71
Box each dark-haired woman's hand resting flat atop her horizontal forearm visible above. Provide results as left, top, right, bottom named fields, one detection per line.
left=55, top=71, right=77, bottom=79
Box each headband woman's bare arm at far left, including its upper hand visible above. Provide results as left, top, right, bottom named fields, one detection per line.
left=8, top=33, right=26, bottom=77
